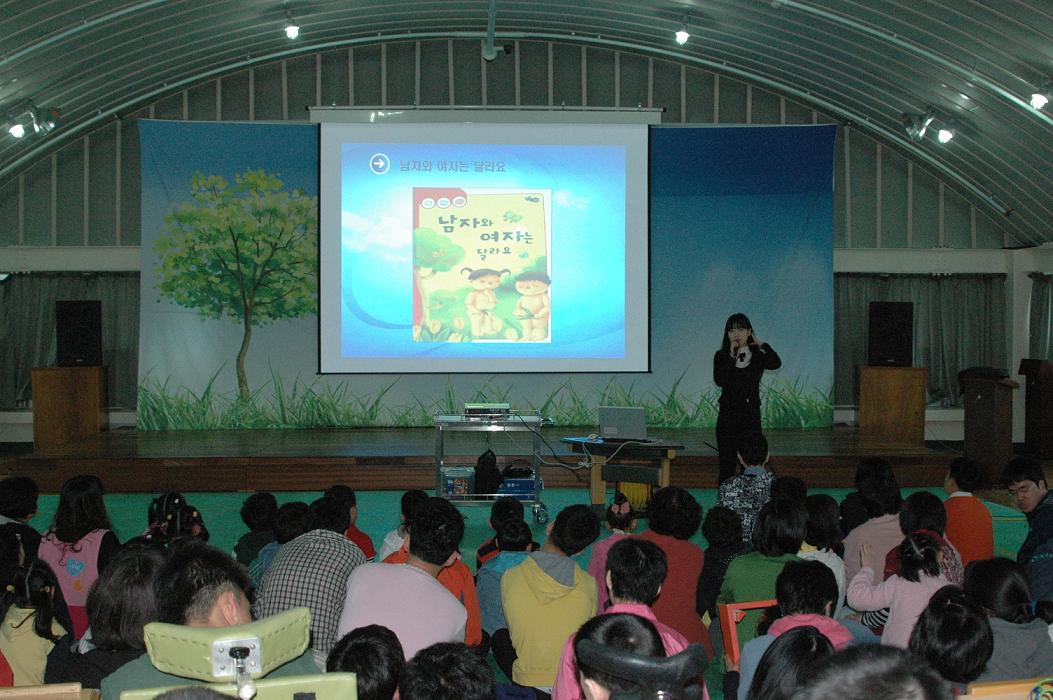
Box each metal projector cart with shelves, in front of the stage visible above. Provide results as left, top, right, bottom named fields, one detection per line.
left=434, top=411, right=549, bottom=525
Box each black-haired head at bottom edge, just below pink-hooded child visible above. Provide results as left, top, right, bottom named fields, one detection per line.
left=738, top=625, right=835, bottom=700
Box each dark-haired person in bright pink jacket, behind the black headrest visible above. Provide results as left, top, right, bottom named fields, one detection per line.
left=552, top=538, right=688, bottom=700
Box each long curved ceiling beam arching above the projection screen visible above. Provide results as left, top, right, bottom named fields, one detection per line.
left=0, top=30, right=1010, bottom=225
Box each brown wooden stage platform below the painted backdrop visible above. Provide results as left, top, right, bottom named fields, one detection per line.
left=0, top=425, right=958, bottom=493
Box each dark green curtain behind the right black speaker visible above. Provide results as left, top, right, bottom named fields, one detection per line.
left=834, top=273, right=1008, bottom=406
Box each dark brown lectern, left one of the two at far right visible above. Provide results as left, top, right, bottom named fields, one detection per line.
left=961, top=378, right=1019, bottom=486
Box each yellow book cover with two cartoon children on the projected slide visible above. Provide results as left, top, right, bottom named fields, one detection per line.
left=413, top=187, right=553, bottom=343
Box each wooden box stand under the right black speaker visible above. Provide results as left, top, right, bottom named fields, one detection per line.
left=858, top=365, right=928, bottom=446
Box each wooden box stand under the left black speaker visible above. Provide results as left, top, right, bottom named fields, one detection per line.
left=33, top=367, right=106, bottom=451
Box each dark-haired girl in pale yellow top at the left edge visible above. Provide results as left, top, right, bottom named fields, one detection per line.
left=0, top=559, right=65, bottom=686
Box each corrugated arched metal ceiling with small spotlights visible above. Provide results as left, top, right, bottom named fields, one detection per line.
left=0, top=0, right=1053, bottom=245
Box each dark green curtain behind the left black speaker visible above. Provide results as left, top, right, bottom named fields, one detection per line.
left=0, top=273, right=139, bottom=409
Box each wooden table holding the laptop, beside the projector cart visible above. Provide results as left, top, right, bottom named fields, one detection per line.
left=560, top=437, right=683, bottom=505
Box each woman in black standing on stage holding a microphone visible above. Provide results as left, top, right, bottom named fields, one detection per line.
left=713, top=314, right=782, bottom=484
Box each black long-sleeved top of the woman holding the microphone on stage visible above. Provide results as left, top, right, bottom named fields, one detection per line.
left=713, top=343, right=782, bottom=433
